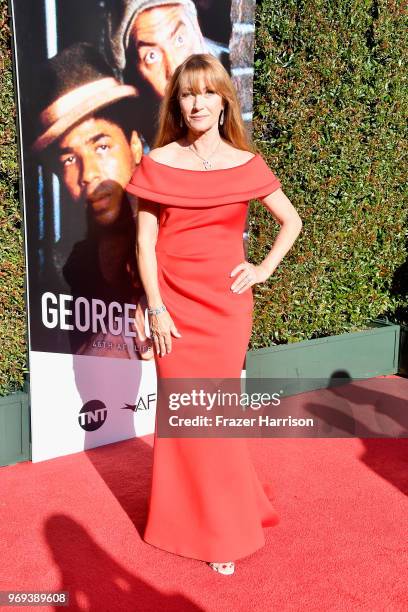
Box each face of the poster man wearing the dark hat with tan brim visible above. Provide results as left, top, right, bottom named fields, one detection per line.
left=56, top=116, right=142, bottom=226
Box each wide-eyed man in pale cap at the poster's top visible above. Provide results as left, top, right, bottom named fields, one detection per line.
left=109, top=0, right=229, bottom=98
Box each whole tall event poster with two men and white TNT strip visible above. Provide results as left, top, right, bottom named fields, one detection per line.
left=11, top=0, right=255, bottom=461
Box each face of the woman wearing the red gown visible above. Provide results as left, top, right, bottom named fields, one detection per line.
left=179, top=75, right=224, bottom=133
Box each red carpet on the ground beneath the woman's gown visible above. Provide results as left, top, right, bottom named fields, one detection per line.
left=0, top=378, right=408, bottom=612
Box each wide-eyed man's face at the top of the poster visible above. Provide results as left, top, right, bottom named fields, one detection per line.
left=128, top=4, right=205, bottom=97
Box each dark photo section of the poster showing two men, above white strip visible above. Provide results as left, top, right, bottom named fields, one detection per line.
left=12, top=0, right=254, bottom=360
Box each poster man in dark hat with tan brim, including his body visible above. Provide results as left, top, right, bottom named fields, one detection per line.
left=32, top=43, right=153, bottom=359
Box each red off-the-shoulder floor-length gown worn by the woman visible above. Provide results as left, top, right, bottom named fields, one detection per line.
left=126, top=153, right=280, bottom=561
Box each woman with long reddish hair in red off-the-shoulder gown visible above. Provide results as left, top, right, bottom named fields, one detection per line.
left=127, top=54, right=301, bottom=574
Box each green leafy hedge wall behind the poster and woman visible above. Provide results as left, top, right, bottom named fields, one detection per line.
left=0, top=0, right=408, bottom=394
